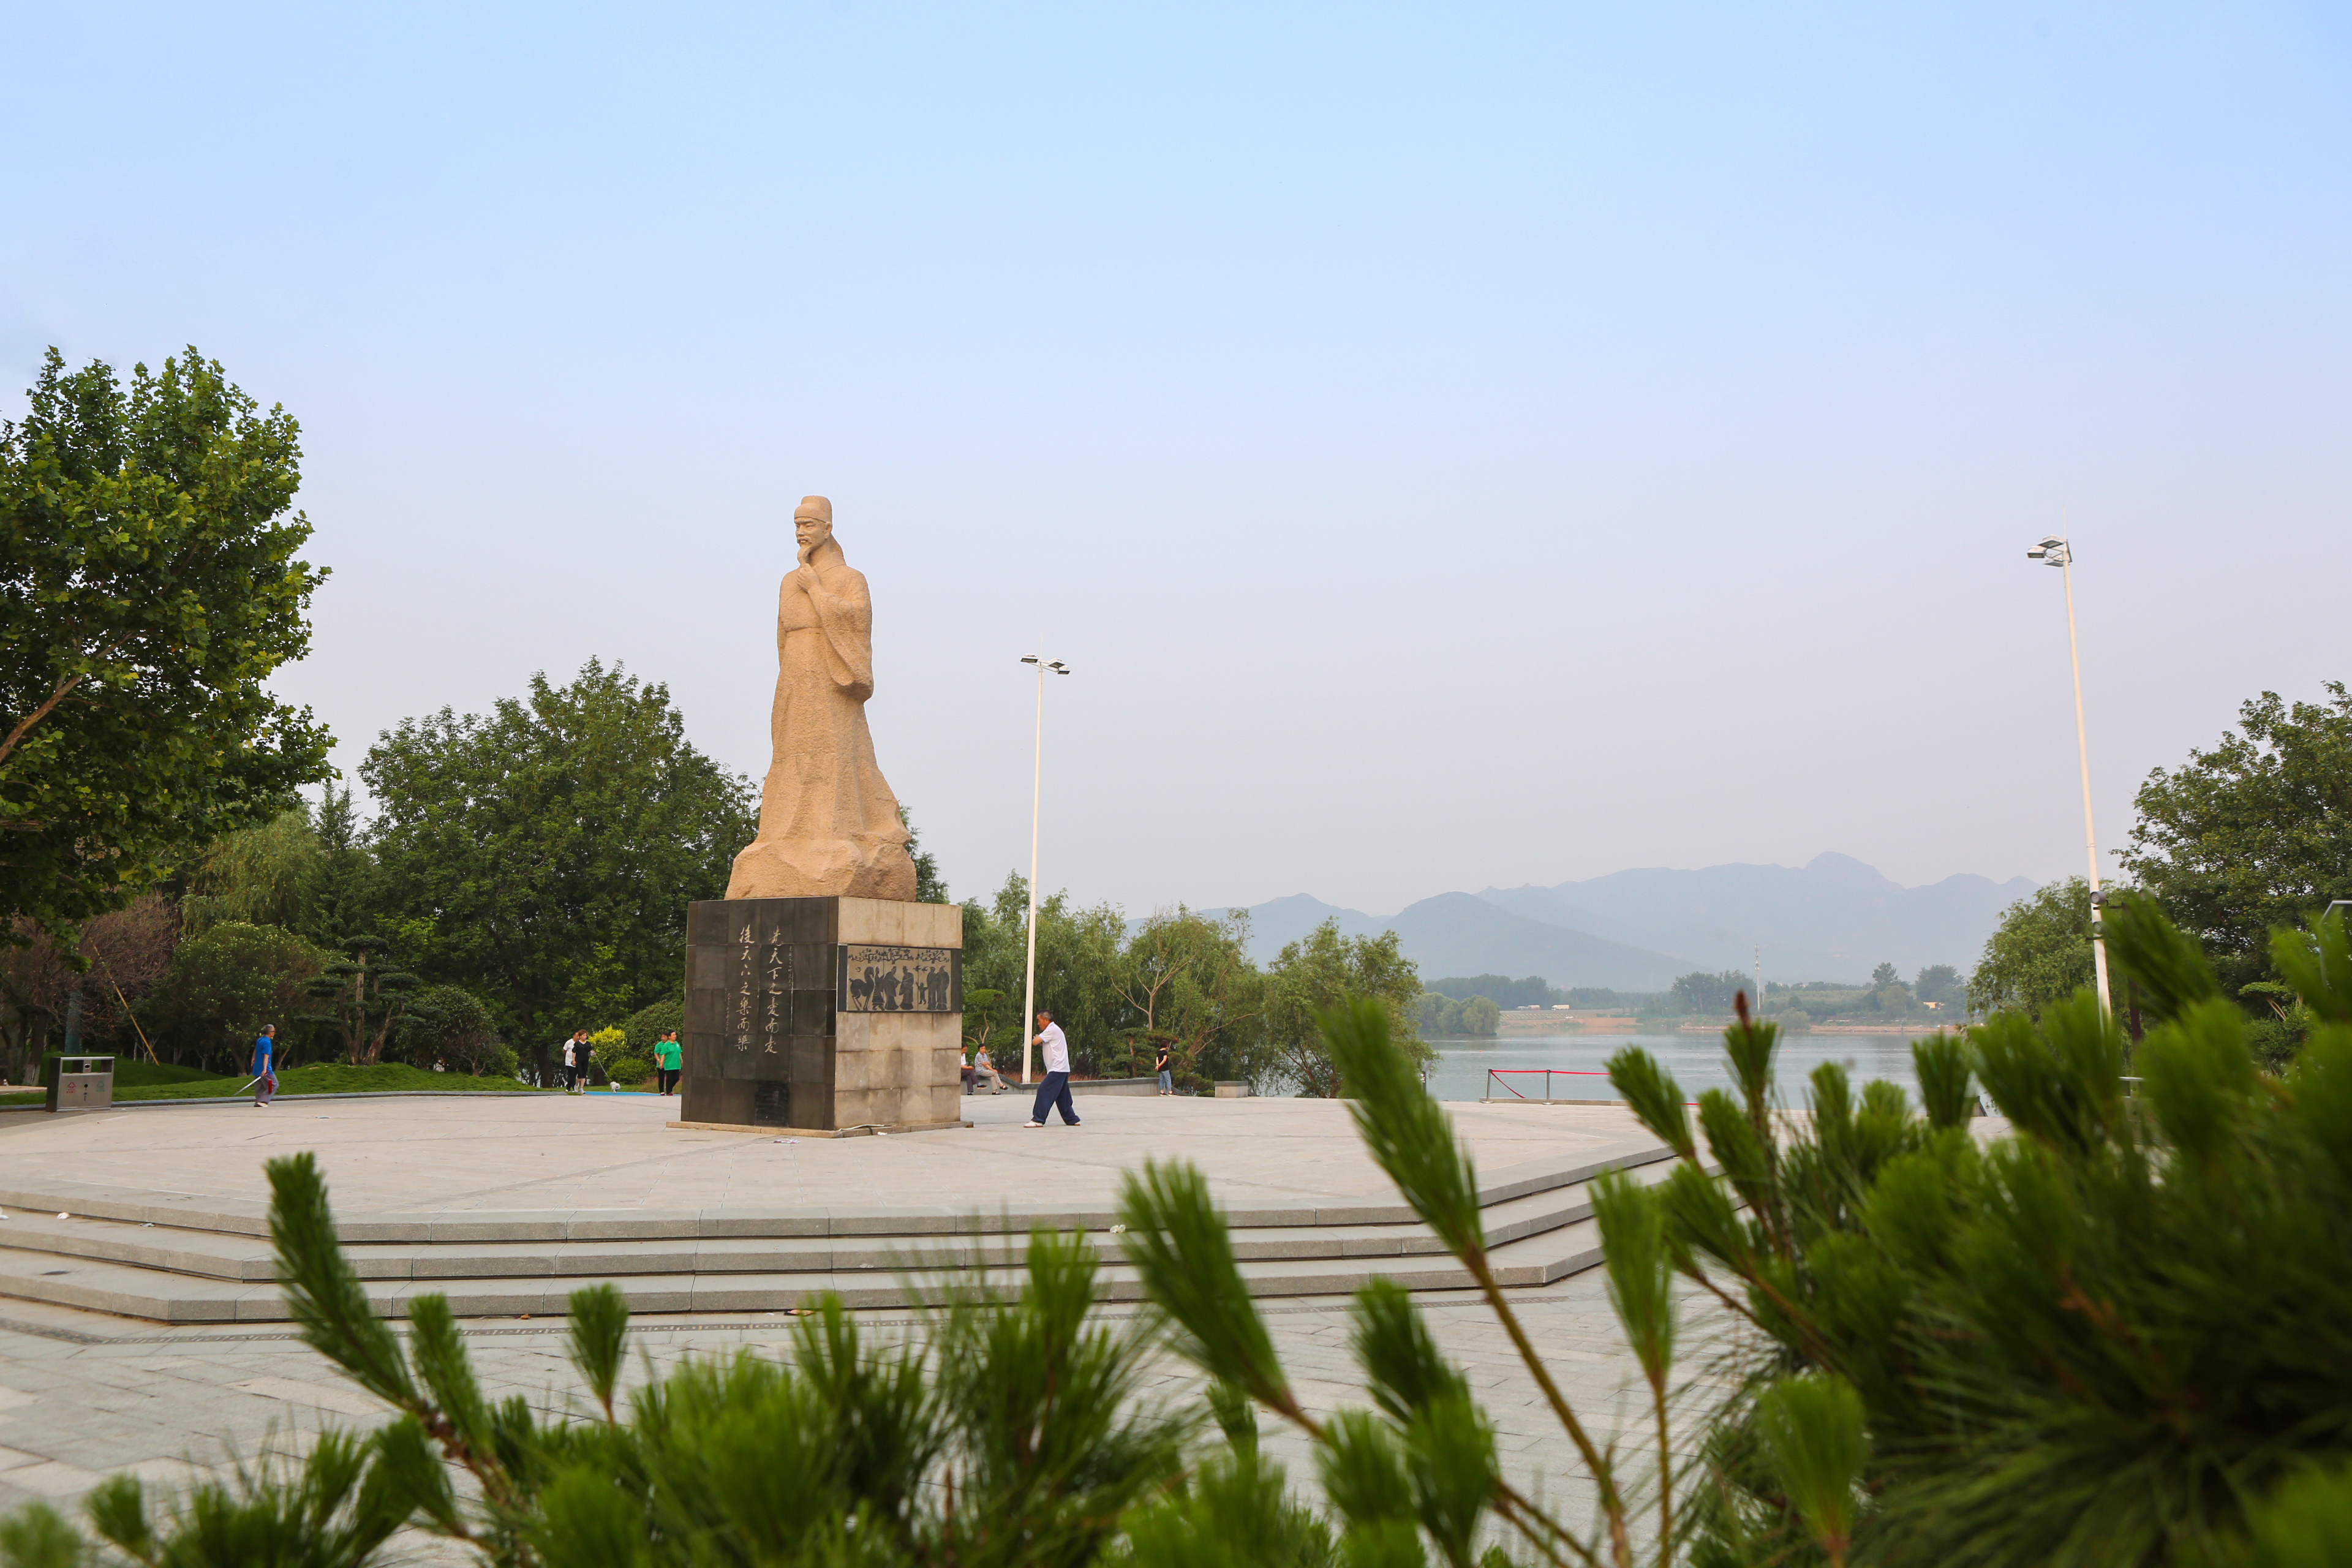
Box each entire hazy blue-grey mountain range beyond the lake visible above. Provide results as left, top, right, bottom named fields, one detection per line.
left=1213, top=856, right=2035, bottom=990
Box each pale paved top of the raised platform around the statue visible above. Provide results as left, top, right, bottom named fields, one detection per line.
left=0, top=1086, right=1656, bottom=1220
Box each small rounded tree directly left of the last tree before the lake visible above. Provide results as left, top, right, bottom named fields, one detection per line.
left=1122, top=905, right=1265, bottom=1086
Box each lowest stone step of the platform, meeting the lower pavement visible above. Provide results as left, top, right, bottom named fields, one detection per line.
left=0, top=1218, right=1602, bottom=1324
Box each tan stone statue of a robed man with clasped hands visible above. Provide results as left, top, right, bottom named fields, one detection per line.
left=727, top=496, right=915, bottom=903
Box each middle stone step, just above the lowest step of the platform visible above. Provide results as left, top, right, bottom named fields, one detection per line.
left=0, top=1161, right=1672, bottom=1293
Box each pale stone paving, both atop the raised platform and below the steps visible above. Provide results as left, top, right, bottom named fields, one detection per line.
left=0, top=1091, right=1731, bottom=1561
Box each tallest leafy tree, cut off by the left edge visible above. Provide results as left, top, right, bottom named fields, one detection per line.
left=0, top=348, right=330, bottom=940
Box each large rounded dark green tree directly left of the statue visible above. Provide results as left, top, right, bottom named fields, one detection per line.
left=360, top=661, right=757, bottom=1067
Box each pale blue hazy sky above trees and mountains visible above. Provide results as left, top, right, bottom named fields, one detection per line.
left=13, top=0, right=2352, bottom=912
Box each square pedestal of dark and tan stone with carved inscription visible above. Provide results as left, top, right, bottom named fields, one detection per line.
left=680, top=898, right=964, bottom=1131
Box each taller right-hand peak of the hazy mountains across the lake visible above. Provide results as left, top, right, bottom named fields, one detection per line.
left=1479, top=856, right=2035, bottom=980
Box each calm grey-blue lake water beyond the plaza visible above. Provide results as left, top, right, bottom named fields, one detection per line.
left=1430, top=1035, right=1919, bottom=1107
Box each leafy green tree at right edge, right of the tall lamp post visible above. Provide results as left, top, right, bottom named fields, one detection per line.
left=2119, top=682, right=2352, bottom=997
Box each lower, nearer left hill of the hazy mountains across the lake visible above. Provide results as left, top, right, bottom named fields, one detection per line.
left=1249, top=893, right=1696, bottom=990
